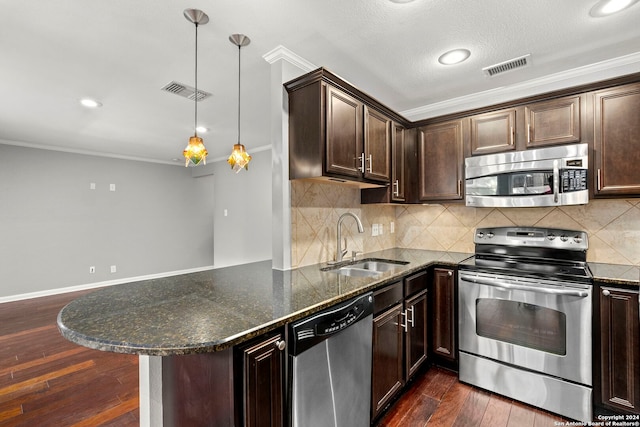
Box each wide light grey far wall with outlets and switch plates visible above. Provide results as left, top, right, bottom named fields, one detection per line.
left=0, top=144, right=214, bottom=301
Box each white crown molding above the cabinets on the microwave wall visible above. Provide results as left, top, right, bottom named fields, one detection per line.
left=400, top=52, right=640, bottom=121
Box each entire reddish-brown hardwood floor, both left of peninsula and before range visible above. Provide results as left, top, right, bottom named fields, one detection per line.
left=0, top=292, right=567, bottom=427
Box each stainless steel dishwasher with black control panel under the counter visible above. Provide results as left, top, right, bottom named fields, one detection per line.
left=289, top=293, right=373, bottom=427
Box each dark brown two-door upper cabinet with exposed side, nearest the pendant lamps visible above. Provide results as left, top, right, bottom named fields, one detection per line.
left=285, top=69, right=399, bottom=188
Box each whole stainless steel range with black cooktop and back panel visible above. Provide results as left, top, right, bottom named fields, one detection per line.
left=458, top=227, right=593, bottom=422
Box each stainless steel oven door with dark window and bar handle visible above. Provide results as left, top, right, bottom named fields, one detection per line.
left=458, top=271, right=592, bottom=386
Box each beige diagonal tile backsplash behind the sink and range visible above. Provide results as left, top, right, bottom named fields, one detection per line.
left=291, top=181, right=640, bottom=268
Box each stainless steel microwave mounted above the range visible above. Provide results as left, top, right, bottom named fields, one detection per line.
left=464, top=144, right=589, bottom=207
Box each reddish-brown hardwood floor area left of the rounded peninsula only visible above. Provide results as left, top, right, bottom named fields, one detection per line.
left=0, top=292, right=140, bottom=427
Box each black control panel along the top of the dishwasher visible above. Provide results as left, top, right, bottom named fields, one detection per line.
left=289, top=293, right=373, bottom=355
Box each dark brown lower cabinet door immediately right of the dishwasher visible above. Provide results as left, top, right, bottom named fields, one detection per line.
left=371, top=304, right=404, bottom=418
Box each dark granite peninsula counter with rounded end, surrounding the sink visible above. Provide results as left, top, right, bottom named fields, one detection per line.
left=58, top=249, right=470, bottom=356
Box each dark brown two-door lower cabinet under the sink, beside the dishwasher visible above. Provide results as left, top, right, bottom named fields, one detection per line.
left=371, top=271, right=428, bottom=419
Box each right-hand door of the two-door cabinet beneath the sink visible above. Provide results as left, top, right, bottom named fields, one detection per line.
left=405, top=290, right=428, bottom=380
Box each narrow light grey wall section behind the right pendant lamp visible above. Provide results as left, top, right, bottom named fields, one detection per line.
left=207, top=147, right=272, bottom=268
